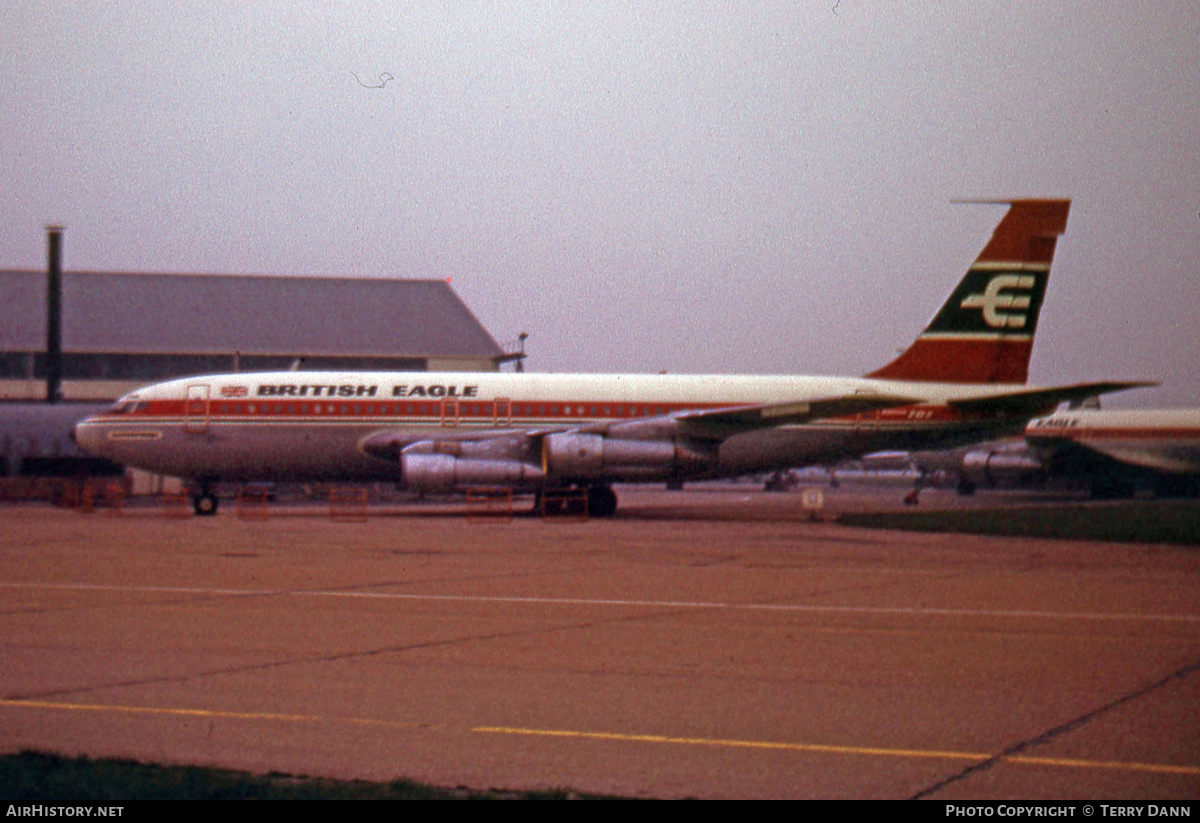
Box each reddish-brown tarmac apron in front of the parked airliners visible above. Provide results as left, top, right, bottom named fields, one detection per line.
left=0, top=486, right=1200, bottom=800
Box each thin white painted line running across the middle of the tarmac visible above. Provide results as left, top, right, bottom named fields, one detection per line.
left=0, top=582, right=1200, bottom=623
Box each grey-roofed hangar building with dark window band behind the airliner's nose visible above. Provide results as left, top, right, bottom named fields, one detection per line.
left=0, top=270, right=520, bottom=402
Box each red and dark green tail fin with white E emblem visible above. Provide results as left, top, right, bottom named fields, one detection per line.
left=866, top=200, right=1070, bottom=383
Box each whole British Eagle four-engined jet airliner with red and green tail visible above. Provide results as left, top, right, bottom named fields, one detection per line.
left=74, top=199, right=1142, bottom=516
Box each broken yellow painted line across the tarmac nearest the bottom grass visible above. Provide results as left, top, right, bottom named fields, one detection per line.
left=0, top=699, right=1200, bottom=775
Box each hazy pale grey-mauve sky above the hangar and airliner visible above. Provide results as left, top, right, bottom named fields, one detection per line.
left=0, top=0, right=1200, bottom=406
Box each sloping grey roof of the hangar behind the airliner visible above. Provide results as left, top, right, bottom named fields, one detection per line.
left=0, top=270, right=504, bottom=358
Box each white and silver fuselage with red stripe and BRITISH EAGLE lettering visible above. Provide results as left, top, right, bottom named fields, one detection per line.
left=76, top=372, right=1041, bottom=486
